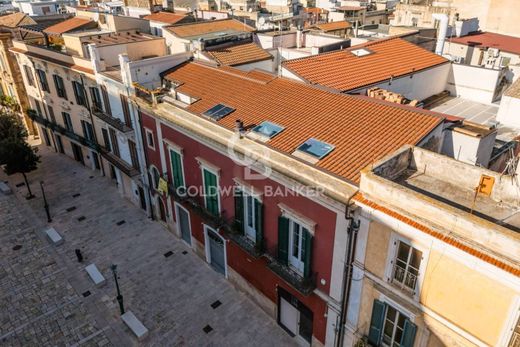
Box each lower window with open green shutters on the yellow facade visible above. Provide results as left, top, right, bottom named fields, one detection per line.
left=368, top=300, right=417, bottom=347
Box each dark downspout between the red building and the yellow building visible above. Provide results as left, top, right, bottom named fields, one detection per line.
left=335, top=190, right=360, bottom=347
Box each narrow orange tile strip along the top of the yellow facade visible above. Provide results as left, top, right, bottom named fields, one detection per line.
left=353, top=193, right=520, bottom=277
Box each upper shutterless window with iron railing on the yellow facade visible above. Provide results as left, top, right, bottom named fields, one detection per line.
left=392, top=241, right=422, bottom=290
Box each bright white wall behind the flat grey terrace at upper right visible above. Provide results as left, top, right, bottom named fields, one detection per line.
left=446, top=64, right=501, bottom=104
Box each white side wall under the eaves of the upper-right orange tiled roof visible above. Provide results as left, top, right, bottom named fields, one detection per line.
left=350, top=63, right=451, bottom=100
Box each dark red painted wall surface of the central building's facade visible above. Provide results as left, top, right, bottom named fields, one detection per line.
left=142, top=114, right=336, bottom=342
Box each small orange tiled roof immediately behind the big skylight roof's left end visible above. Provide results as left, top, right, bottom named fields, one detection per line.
left=206, top=42, right=273, bottom=66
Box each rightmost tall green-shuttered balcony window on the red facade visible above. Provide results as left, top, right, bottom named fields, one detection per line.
left=278, top=216, right=313, bottom=278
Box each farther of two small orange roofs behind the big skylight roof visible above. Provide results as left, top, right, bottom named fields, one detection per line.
left=166, top=19, right=255, bottom=38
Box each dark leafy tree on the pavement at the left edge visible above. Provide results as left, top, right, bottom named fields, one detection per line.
left=0, top=109, right=40, bottom=199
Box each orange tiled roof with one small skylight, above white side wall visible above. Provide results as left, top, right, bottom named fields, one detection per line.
left=283, top=37, right=448, bottom=91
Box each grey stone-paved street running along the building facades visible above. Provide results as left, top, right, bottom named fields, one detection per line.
left=0, top=146, right=294, bottom=346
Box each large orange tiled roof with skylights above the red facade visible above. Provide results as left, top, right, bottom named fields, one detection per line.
left=165, top=63, right=443, bottom=182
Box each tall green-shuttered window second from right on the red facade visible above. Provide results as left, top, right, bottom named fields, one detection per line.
left=235, top=188, right=263, bottom=246
